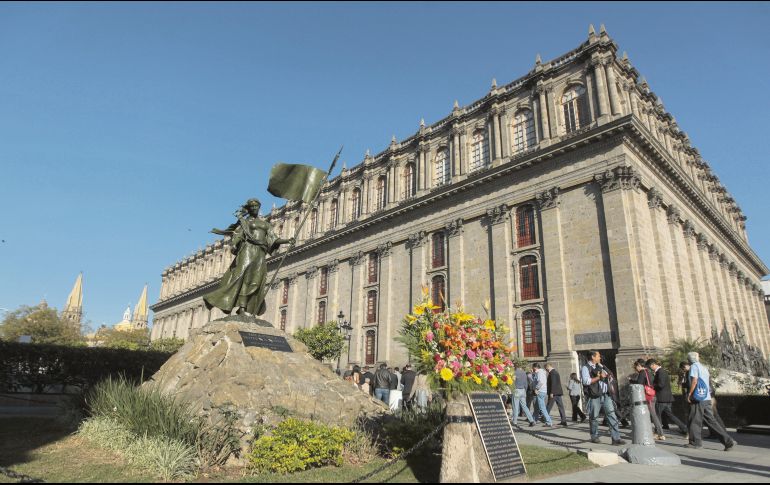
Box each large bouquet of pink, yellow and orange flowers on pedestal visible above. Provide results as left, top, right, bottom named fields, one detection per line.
left=399, top=289, right=513, bottom=393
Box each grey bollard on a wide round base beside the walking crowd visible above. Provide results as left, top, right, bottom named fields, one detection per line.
left=622, top=384, right=682, bottom=465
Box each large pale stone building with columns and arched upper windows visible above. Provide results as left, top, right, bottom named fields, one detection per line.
left=147, top=25, right=770, bottom=375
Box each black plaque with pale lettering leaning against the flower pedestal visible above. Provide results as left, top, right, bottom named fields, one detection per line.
left=468, top=392, right=527, bottom=481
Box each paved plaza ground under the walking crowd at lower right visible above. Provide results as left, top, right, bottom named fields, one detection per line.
left=516, top=420, right=770, bottom=483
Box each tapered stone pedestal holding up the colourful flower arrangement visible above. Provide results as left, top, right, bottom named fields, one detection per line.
left=439, top=396, right=495, bottom=483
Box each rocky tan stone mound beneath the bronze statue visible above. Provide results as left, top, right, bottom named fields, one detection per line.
left=145, top=315, right=387, bottom=458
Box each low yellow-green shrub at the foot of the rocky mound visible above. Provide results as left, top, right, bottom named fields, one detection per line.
left=248, top=418, right=354, bottom=473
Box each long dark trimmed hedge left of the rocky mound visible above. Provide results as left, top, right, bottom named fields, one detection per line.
left=0, top=341, right=173, bottom=393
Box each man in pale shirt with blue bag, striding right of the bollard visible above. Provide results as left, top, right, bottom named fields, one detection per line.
left=684, top=352, right=737, bottom=451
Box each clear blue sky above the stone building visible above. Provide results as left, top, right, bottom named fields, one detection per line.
left=0, top=2, right=770, bottom=326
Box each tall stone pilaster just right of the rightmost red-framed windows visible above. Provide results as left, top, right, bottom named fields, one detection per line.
left=536, top=187, right=574, bottom=355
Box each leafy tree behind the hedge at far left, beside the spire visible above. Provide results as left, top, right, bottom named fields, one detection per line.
left=0, top=304, right=85, bottom=346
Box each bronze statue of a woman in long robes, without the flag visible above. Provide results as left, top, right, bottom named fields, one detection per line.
left=203, top=199, right=294, bottom=315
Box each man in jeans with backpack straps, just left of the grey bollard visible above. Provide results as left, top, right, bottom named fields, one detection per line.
left=580, top=350, right=626, bottom=446
